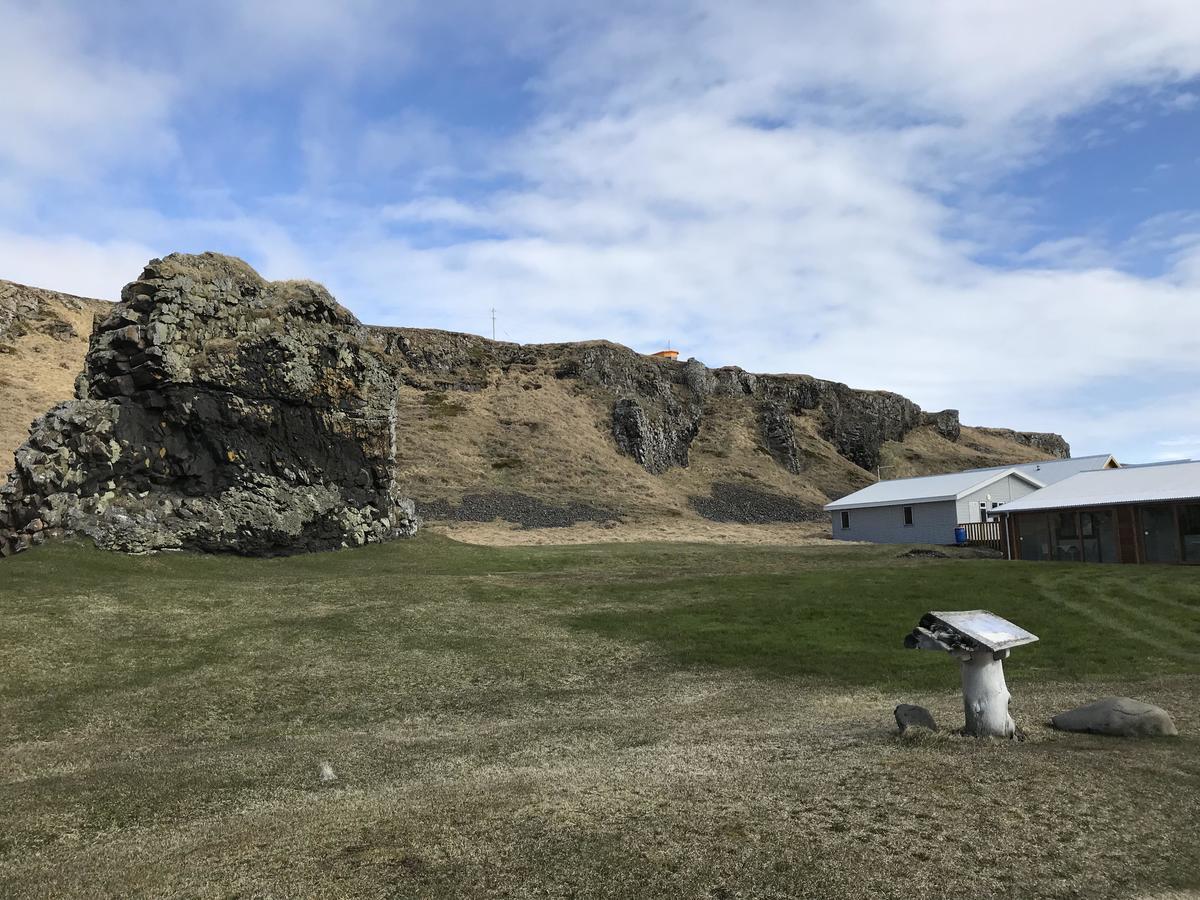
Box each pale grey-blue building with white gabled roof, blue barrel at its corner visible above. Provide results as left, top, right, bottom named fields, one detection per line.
left=824, top=454, right=1118, bottom=544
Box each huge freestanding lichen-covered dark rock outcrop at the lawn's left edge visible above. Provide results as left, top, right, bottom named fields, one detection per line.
left=0, top=253, right=418, bottom=556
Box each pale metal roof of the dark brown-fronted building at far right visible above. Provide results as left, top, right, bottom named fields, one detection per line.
left=992, top=462, right=1200, bottom=512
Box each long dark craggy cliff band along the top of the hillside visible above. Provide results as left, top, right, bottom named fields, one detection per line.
left=376, top=329, right=1070, bottom=474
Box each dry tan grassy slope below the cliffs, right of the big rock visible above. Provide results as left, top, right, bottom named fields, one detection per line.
left=396, top=362, right=1049, bottom=540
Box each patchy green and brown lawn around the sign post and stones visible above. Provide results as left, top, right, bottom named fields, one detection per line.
left=0, top=534, right=1200, bottom=898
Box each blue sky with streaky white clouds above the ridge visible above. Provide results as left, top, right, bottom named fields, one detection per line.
left=0, top=0, right=1200, bottom=462
